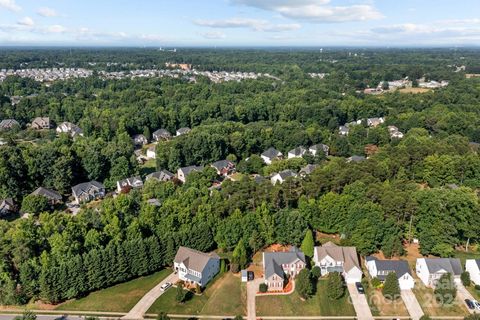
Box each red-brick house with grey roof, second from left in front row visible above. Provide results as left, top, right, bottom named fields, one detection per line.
left=263, top=247, right=306, bottom=291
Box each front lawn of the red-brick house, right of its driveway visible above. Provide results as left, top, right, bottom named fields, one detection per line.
left=257, top=280, right=355, bottom=317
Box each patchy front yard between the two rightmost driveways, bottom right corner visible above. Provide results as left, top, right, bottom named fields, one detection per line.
left=413, top=281, right=468, bottom=316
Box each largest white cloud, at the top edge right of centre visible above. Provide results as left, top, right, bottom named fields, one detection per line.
left=231, top=0, right=383, bottom=23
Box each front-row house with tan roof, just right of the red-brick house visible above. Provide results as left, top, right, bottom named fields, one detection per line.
left=313, top=242, right=362, bottom=283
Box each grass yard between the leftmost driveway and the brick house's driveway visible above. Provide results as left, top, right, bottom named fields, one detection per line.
left=147, top=272, right=247, bottom=316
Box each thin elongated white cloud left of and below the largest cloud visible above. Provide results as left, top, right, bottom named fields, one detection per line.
left=193, top=18, right=301, bottom=32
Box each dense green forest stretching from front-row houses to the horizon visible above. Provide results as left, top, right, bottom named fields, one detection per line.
left=0, top=49, right=480, bottom=304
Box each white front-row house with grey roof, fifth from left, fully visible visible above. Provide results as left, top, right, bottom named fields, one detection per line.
left=415, top=258, right=463, bottom=287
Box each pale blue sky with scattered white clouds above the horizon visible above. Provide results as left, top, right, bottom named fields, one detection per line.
left=0, top=0, right=480, bottom=47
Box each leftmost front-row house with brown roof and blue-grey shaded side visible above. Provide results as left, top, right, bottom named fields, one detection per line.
left=173, top=247, right=220, bottom=287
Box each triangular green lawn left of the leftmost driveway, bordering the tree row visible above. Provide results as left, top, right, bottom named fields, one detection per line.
left=57, top=269, right=172, bottom=312
